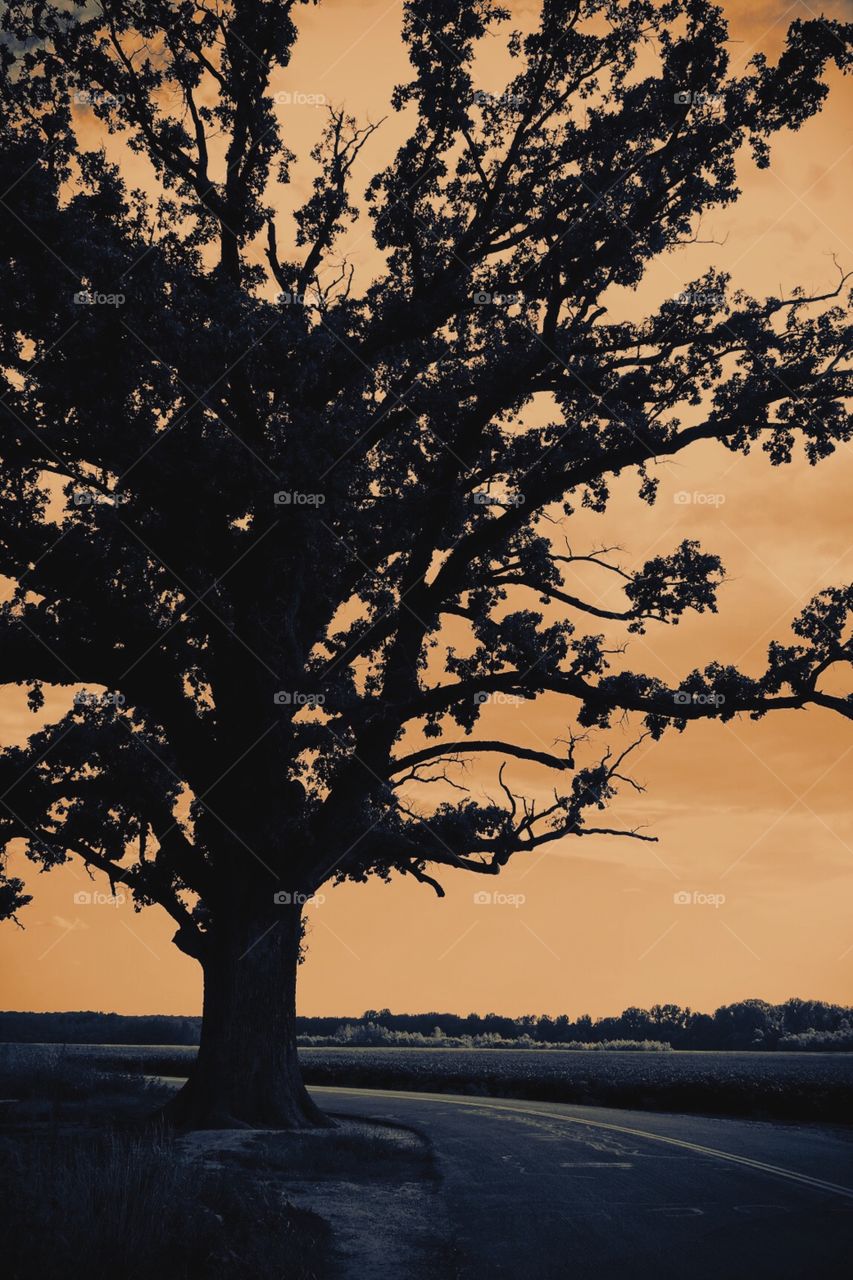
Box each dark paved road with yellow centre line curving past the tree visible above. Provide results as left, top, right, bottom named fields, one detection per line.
left=311, top=1088, right=853, bottom=1280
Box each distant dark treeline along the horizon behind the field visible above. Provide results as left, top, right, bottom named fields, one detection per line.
left=0, top=998, right=853, bottom=1051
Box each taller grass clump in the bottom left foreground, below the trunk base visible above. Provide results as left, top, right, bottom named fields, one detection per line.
left=0, top=1132, right=328, bottom=1280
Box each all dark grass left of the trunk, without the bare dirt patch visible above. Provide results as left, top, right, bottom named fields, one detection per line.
left=0, top=1044, right=329, bottom=1280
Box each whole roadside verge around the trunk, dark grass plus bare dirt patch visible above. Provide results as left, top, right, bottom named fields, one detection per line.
left=0, top=1044, right=441, bottom=1280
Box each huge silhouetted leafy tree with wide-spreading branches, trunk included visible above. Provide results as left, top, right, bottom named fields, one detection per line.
left=0, top=0, right=853, bottom=1125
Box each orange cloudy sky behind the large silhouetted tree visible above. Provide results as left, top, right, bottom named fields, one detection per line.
left=0, top=0, right=853, bottom=1015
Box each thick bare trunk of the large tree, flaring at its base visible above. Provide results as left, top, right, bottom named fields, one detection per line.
left=165, top=904, right=332, bottom=1129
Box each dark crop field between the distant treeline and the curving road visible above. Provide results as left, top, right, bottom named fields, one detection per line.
left=8, top=1044, right=853, bottom=1124
